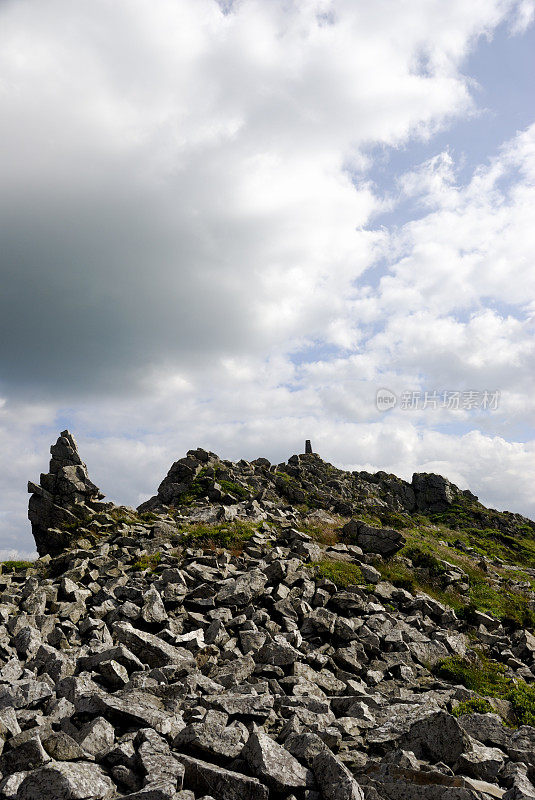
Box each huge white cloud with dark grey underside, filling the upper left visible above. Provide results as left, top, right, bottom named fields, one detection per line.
left=0, top=0, right=516, bottom=397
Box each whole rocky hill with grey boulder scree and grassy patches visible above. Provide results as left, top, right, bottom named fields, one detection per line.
left=0, top=431, right=535, bottom=800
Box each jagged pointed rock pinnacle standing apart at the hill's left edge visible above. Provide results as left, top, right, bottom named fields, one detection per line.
left=28, top=431, right=110, bottom=556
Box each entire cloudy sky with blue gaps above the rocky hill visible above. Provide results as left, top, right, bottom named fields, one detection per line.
left=0, top=0, right=535, bottom=558
